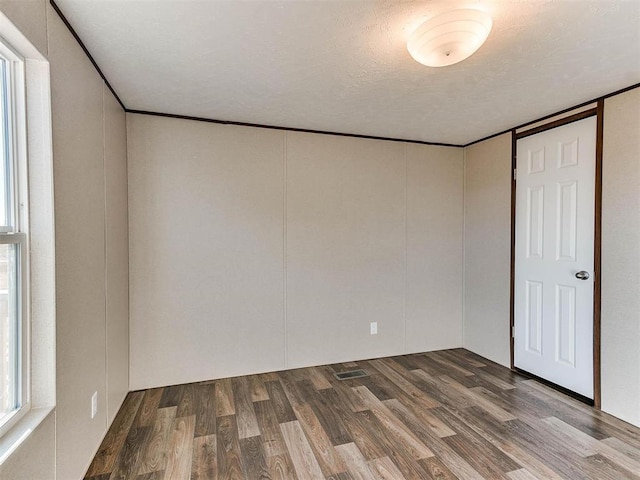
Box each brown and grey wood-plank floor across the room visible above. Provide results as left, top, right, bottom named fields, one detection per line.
left=85, top=349, right=640, bottom=480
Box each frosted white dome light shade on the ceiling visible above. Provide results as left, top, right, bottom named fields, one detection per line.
left=407, top=9, right=493, bottom=67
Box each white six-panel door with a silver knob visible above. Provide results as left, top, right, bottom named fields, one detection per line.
left=514, top=116, right=596, bottom=398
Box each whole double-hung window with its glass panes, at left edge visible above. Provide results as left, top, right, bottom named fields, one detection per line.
left=0, top=42, right=30, bottom=434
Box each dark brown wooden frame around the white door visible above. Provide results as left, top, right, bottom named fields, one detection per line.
left=509, top=98, right=604, bottom=409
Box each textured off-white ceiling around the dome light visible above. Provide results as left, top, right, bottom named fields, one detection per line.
left=56, top=0, right=640, bottom=145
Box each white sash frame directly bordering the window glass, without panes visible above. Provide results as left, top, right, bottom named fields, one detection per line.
left=0, top=38, right=31, bottom=438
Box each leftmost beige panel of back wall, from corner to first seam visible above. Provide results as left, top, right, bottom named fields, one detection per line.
left=127, top=115, right=284, bottom=389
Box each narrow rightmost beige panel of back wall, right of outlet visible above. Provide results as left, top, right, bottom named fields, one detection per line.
left=405, top=144, right=463, bottom=352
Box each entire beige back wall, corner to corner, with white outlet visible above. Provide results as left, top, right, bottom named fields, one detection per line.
left=127, top=114, right=462, bottom=388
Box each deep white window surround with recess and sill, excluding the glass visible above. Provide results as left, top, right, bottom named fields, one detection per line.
left=0, top=11, right=56, bottom=466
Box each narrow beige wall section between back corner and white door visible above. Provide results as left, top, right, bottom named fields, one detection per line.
left=464, top=133, right=511, bottom=366
